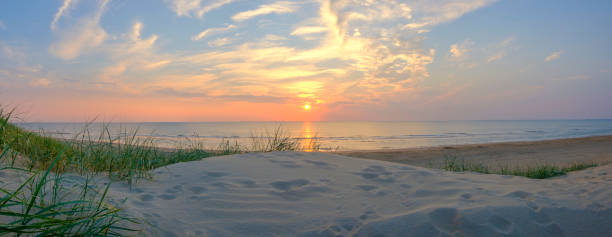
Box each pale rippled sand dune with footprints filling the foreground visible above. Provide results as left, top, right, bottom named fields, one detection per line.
left=99, top=152, right=612, bottom=236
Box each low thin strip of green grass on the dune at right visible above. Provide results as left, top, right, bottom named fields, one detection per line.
left=437, top=157, right=597, bottom=179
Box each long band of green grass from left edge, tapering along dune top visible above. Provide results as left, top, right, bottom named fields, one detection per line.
left=0, top=108, right=218, bottom=183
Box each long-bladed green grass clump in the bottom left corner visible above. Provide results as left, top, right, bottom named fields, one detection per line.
left=0, top=157, right=136, bottom=236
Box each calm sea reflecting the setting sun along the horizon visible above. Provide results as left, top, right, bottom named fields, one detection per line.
left=19, top=120, right=612, bottom=150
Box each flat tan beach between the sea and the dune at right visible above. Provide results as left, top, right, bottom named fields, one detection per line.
left=336, top=136, right=612, bottom=167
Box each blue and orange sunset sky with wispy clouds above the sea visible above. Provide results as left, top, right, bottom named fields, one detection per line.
left=0, top=0, right=612, bottom=122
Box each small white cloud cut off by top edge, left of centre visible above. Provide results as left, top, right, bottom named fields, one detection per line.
left=166, top=0, right=234, bottom=18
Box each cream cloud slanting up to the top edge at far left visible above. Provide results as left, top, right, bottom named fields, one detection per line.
left=49, top=0, right=110, bottom=60
